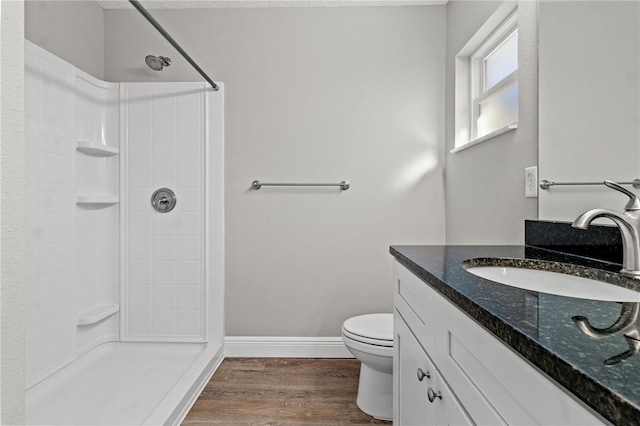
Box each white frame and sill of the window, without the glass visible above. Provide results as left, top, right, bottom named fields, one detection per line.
left=451, top=1, right=518, bottom=152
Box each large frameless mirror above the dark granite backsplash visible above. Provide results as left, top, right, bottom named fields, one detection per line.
left=538, top=0, right=640, bottom=221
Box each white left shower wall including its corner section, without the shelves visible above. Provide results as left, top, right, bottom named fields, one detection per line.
left=25, top=41, right=120, bottom=388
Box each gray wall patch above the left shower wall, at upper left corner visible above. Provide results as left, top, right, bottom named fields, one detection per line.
left=24, top=0, right=104, bottom=79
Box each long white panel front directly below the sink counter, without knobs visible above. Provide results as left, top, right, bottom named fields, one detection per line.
left=430, top=298, right=602, bottom=425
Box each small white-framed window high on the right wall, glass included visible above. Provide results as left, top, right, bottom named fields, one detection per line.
left=453, top=6, right=518, bottom=152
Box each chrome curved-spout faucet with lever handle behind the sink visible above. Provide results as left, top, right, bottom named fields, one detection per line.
left=571, top=180, right=640, bottom=279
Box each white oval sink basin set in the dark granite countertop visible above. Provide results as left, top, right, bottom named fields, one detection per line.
left=465, top=266, right=640, bottom=302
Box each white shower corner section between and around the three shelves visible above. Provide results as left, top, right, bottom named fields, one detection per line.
left=75, top=71, right=120, bottom=355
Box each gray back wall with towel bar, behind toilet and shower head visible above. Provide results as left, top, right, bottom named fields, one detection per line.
left=105, top=6, right=446, bottom=336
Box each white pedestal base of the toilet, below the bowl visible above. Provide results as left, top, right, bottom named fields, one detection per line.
left=356, top=363, right=393, bottom=420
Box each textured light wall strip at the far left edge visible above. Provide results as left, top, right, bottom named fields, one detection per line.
left=0, top=1, right=25, bottom=425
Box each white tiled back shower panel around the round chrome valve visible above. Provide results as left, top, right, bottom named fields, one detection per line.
left=121, top=83, right=205, bottom=341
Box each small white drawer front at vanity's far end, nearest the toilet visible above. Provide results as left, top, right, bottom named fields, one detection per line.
left=393, top=261, right=437, bottom=352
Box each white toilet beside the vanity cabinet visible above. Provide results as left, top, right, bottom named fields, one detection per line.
left=342, top=314, right=393, bottom=420
